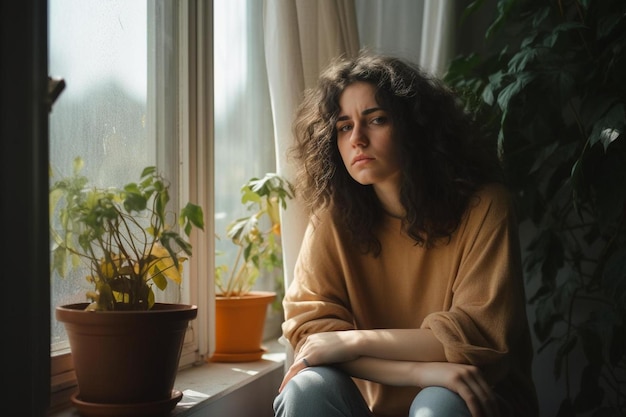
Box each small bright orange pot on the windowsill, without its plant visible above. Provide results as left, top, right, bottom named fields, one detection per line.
left=211, top=291, right=276, bottom=362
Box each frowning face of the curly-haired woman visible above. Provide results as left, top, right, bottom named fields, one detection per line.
left=336, top=82, right=401, bottom=192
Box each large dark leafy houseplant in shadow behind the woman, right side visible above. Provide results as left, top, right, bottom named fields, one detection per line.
left=446, top=0, right=626, bottom=417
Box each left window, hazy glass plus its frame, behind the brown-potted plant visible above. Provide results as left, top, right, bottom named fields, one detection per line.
left=48, top=0, right=214, bottom=409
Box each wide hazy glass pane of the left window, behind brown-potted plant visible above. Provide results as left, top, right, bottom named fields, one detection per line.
left=49, top=0, right=150, bottom=350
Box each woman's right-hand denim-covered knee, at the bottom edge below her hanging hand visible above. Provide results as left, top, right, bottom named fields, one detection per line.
left=409, top=387, right=471, bottom=417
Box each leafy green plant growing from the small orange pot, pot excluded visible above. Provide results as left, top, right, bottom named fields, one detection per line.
left=215, top=173, right=294, bottom=297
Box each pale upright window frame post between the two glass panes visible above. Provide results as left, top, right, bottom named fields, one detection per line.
left=174, top=0, right=215, bottom=366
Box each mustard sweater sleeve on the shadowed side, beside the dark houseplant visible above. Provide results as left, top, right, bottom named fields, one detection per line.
left=422, top=187, right=527, bottom=381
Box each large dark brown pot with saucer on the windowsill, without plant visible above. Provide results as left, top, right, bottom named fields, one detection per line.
left=56, top=303, right=198, bottom=416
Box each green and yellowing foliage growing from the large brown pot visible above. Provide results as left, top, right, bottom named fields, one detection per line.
left=50, top=158, right=204, bottom=310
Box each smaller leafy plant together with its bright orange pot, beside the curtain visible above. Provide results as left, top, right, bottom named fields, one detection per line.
left=211, top=173, right=294, bottom=362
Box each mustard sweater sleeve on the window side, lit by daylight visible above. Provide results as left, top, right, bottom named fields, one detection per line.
left=283, top=213, right=354, bottom=353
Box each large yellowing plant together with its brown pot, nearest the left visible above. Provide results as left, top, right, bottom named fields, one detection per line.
left=49, top=158, right=204, bottom=416
